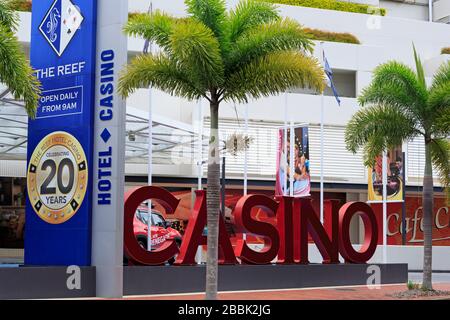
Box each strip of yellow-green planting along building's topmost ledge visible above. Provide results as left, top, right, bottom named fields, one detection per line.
left=261, top=0, right=386, bottom=16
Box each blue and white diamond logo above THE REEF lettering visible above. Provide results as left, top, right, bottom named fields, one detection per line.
left=39, top=0, right=84, bottom=57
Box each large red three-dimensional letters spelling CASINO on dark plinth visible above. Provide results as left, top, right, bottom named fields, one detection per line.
left=124, top=186, right=378, bottom=266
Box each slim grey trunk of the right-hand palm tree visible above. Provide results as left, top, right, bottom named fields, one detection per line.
left=422, top=138, right=433, bottom=290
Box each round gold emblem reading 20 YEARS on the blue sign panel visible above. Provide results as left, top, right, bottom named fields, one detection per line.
left=27, top=131, right=88, bottom=224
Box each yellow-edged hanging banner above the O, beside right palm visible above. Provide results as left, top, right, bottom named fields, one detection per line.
left=367, top=146, right=404, bottom=201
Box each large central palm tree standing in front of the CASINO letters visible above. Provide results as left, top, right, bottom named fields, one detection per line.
left=119, top=0, right=324, bottom=299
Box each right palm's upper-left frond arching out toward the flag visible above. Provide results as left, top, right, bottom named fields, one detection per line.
left=358, top=61, right=428, bottom=126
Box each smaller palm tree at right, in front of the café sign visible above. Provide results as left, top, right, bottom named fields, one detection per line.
left=345, top=48, right=450, bottom=290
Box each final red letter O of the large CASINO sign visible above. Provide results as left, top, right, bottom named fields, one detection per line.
left=339, top=202, right=378, bottom=263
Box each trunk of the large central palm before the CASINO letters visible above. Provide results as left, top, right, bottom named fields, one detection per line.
left=206, top=100, right=220, bottom=300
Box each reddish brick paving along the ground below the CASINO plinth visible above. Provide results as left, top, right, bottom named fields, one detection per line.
left=124, top=283, right=450, bottom=300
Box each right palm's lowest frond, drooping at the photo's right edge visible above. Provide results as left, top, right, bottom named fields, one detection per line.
left=430, top=139, right=450, bottom=201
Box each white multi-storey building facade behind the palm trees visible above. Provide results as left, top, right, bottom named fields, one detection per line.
left=0, top=0, right=450, bottom=250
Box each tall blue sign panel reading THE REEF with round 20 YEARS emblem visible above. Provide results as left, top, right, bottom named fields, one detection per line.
left=25, top=0, right=97, bottom=266
